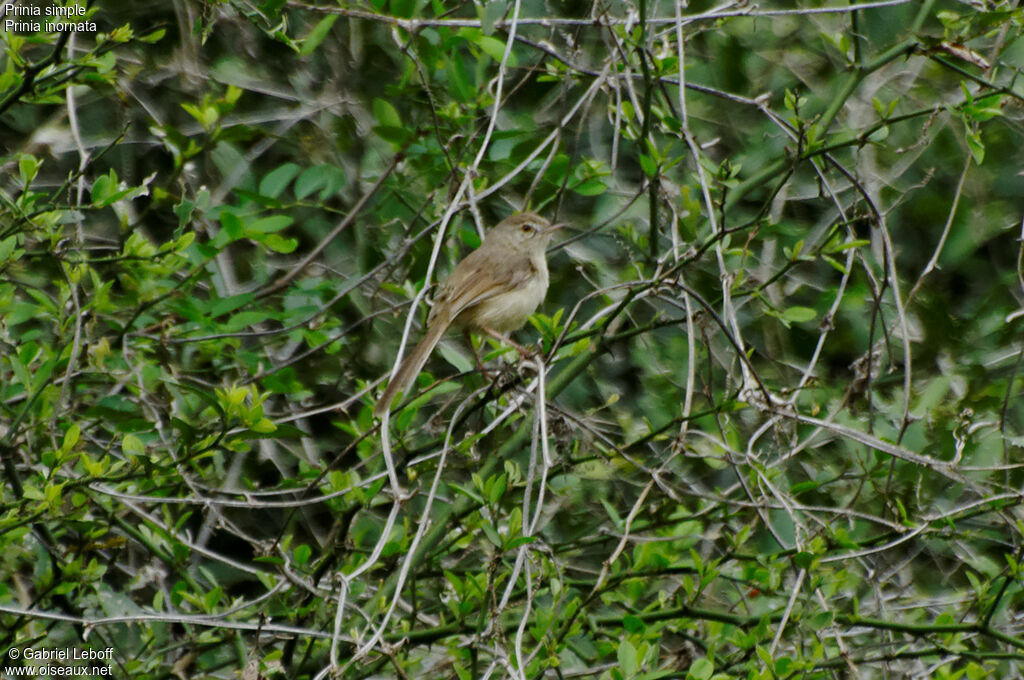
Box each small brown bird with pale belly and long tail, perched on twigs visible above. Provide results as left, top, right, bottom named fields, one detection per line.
left=374, top=212, right=564, bottom=417
